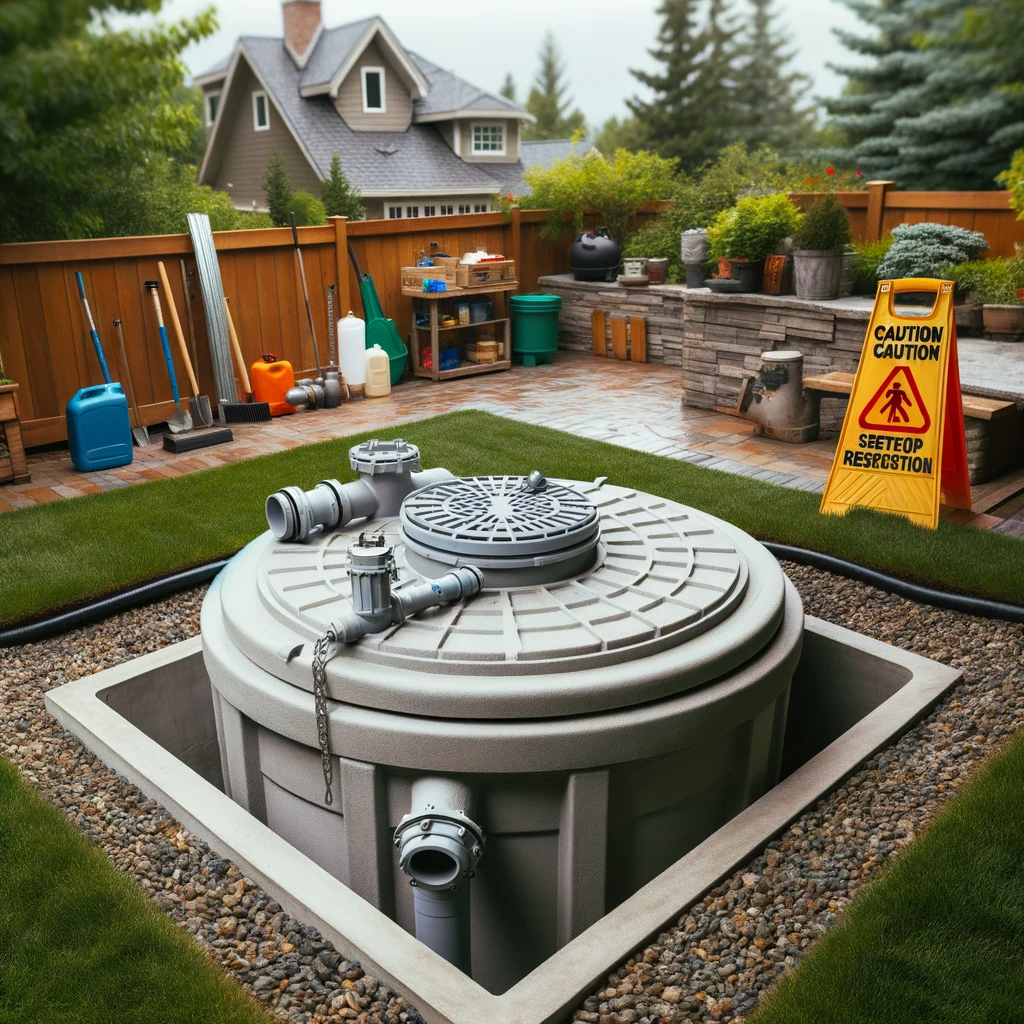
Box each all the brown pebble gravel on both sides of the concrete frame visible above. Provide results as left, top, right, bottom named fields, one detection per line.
left=0, top=563, right=1024, bottom=1024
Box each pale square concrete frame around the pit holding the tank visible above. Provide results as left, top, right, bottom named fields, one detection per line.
left=46, top=616, right=963, bottom=1024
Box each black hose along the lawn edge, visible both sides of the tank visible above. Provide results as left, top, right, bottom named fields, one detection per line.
left=0, top=541, right=1024, bottom=647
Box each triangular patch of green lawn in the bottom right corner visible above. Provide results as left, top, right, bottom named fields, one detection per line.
left=752, top=737, right=1024, bottom=1024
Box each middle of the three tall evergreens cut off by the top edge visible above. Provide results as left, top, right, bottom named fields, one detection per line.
left=736, top=0, right=814, bottom=154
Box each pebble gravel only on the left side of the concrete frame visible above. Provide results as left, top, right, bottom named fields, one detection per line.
left=0, top=587, right=423, bottom=1024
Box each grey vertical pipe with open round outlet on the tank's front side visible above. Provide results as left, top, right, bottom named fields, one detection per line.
left=394, top=776, right=484, bottom=974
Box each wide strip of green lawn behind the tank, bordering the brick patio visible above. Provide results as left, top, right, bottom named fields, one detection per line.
left=0, top=412, right=1024, bottom=624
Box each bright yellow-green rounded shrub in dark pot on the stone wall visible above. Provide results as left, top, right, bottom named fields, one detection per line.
left=708, top=194, right=801, bottom=292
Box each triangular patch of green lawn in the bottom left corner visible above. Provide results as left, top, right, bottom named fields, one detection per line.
left=0, top=759, right=270, bottom=1024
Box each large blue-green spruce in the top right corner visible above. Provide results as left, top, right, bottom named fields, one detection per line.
left=827, top=0, right=1024, bottom=189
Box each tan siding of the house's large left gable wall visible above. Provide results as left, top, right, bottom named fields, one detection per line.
left=204, top=60, right=319, bottom=210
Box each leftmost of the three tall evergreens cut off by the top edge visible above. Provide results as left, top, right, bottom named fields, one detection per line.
left=627, top=0, right=741, bottom=171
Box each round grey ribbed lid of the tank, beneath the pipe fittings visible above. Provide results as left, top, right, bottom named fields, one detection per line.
left=214, top=483, right=784, bottom=718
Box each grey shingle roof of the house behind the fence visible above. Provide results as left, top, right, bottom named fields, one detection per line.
left=242, top=36, right=522, bottom=195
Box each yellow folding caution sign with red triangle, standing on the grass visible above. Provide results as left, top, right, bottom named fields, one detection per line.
left=821, top=278, right=971, bottom=529
